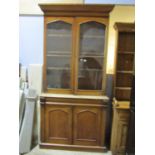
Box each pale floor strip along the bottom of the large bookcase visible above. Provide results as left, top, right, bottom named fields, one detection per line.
left=25, top=146, right=112, bottom=155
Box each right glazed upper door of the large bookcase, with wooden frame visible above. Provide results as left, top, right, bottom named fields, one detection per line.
left=76, top=18, right=108, bottom=94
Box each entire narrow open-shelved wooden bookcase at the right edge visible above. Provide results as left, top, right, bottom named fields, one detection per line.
left=111, top=23, right=135, bottom=155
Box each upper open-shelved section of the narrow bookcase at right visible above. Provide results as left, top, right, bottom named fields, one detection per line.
left=114, top=23, right=135, bottom=101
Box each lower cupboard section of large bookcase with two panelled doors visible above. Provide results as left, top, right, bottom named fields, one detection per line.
left=40, top=97, right=107, bottom=151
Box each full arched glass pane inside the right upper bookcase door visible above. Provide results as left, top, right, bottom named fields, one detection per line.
left=78, top=22, right=105, bottom=90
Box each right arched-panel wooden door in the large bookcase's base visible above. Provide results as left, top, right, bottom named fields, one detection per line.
left=73, top=107, right=101, bottom=146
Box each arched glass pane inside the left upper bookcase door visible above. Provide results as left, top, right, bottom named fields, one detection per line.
left=46, top=21, right=72, bottom=89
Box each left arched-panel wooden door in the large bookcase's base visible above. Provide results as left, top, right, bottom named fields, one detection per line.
left=45, top=105, right=72, bottom=144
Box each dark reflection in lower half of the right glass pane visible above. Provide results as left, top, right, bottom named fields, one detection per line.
left=78, top=57, right=103, bottom=90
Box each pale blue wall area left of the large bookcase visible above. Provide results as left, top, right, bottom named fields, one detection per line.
left=19, top=16, right=43, bottom=67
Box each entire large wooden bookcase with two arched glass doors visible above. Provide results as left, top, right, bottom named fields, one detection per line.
left=40, top=4, right=114, bottom=151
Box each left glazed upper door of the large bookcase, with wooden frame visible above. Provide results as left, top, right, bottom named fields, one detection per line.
left=44, top=17, right=74, bottom=93
